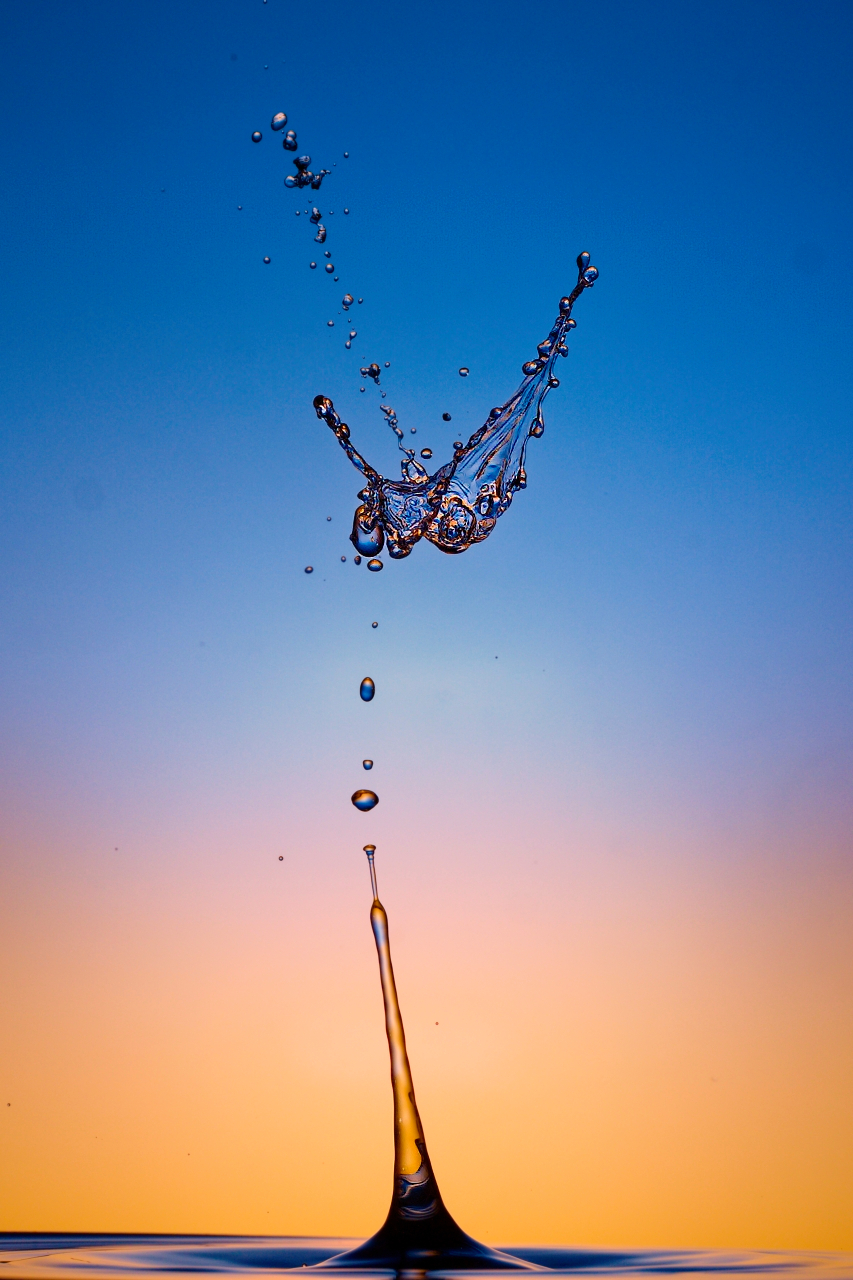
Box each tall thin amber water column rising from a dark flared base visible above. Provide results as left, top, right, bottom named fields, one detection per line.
left=324, top=845, right=527, bottom=1274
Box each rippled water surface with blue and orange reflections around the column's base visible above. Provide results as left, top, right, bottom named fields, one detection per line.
left=0, top=1231, right=853, bottom=1280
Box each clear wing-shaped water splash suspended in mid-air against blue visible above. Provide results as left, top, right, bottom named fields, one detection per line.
left=314, top=253, right=598, bottom=559
